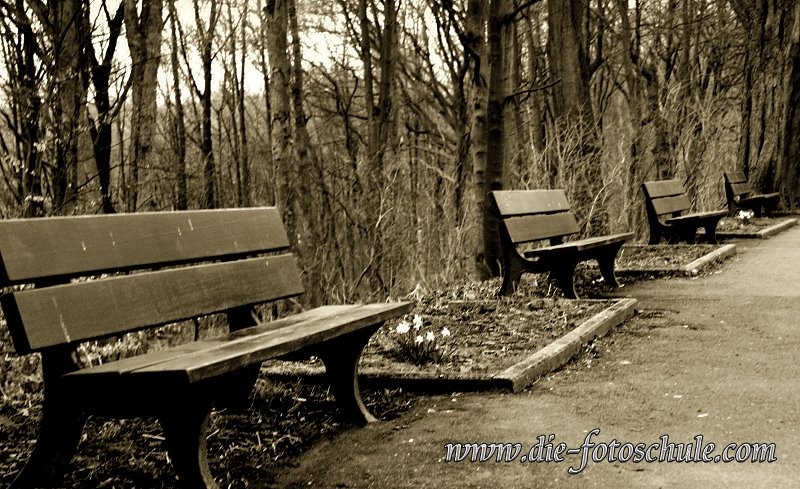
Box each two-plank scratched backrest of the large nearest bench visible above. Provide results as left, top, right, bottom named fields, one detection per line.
left=0, top=208, right=303, bottom=353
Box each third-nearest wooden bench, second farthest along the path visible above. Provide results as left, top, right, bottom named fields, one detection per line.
left=642, top=180, right=727, bottom=244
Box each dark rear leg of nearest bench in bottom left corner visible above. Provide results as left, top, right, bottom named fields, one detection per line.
left=10, top=398, right=86, bottom=489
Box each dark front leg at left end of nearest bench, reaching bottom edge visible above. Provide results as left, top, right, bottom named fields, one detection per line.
left=158, top=392, right=218, bottom=489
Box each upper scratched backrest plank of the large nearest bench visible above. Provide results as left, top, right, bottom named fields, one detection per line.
left=0, top=207, right=289, bottom=286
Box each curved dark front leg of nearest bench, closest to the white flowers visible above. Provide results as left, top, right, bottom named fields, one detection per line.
left=315, top=323, right=383, bottom=425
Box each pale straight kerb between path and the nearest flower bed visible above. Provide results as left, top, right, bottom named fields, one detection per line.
left=494, top=298, right=637, bottom=392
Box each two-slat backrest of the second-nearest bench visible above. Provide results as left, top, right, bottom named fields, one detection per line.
left=491, top=190, right=578, bottom=245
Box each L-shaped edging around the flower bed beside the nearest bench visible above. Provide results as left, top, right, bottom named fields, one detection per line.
left=266, top=298, right=637, bottom=393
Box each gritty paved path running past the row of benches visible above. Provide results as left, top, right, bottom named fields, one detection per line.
left=279, top=228, right=800, bottom=489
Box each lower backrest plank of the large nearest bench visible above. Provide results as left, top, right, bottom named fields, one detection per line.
left=2, top=254, right=303, bottom=352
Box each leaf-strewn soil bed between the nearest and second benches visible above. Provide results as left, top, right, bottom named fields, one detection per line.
left=268, top=275, right=612, bottom=389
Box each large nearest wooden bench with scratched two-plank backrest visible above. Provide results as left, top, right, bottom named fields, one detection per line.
left=0, top=208, right=411, bottom=488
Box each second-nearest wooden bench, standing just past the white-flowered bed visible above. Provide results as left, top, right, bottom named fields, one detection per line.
left=491, top=190, right=633, bottom=299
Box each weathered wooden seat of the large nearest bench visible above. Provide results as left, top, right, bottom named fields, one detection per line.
left=65, top=302, right=413, bottom=383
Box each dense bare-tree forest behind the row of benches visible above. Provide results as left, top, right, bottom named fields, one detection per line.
left=0, top=0, right=800, bottom=303
